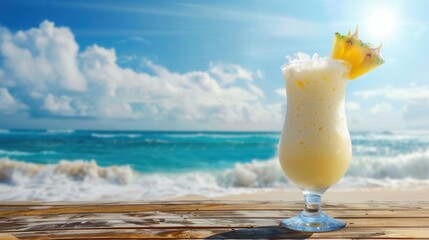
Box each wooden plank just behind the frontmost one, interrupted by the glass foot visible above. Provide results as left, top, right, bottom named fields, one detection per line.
left=0, top=218, right=429, bottom=233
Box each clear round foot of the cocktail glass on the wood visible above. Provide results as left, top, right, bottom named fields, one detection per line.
left=280, top=210, right=346, bottom=232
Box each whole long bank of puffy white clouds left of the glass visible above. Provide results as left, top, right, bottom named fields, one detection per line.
left=0, top=21, right=282, bottom=122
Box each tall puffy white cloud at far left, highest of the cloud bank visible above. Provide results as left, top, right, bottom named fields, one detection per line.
left=0, top=21, right=86, bottom=91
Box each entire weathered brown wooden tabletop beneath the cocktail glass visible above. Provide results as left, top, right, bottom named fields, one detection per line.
left=0, top=201, right=429, bottom=240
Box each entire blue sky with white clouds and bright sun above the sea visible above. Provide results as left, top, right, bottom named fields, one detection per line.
left=0, top=0, right=429, bottom=131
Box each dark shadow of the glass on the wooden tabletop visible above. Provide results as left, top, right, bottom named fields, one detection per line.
left=206, top=226, right=312, bottom=239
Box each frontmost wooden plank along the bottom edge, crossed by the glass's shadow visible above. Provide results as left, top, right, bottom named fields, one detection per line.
left=6, top=226, right=429, bottom=240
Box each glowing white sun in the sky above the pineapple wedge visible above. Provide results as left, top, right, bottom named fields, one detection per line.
left=368, top=9, right=396, bottom=39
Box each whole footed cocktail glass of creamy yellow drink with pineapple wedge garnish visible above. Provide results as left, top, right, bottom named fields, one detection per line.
left=279, top=27, right=384, bottom=232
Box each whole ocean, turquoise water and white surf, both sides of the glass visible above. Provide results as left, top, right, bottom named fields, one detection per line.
left=0, top=130, right=429, bottom=200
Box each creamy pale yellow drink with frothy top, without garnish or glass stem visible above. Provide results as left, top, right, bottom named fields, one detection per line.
left=279, top=54, right=352, bottom=192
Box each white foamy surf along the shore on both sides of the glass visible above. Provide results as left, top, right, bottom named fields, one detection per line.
left=0, top=147, right=429, bottom=200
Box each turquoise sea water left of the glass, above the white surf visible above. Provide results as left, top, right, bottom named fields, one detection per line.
left=0, top=130, right=279, bottom=173
